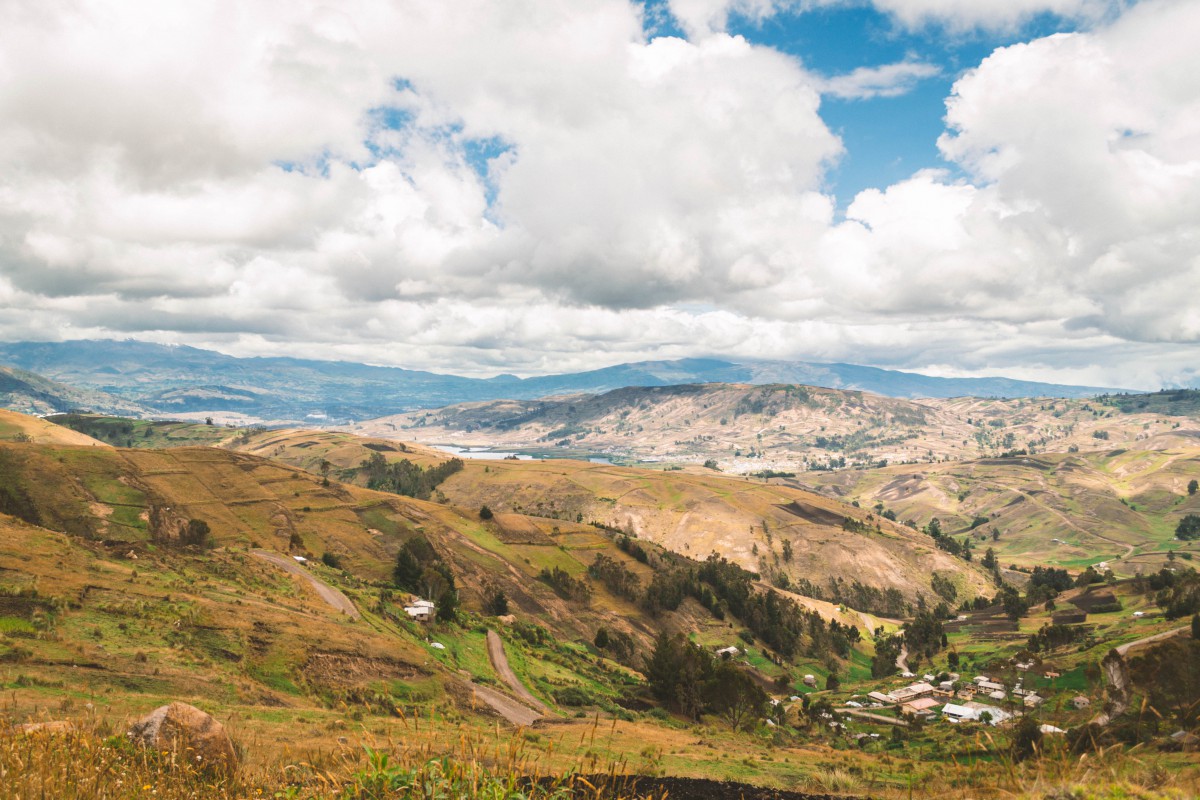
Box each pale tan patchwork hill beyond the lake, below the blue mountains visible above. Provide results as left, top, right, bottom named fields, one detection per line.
left=350, top=384, right=1200, bottom=474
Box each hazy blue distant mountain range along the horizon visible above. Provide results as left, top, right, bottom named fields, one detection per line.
left=0, top=341, right=1118, bottom=421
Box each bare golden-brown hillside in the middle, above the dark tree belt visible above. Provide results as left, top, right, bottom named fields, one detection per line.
left=239, top=431, right=990, bottom=614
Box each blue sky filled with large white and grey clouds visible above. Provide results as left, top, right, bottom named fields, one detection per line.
left=0, top=0, right=1200, bottom=389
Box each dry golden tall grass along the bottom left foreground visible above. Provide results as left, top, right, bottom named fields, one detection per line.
left=0, top=718, right=652, bottom=800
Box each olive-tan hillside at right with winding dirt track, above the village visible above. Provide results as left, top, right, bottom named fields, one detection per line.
left=806, top=447, right=1200, bottom=576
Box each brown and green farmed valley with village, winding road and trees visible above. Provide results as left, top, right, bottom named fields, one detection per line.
left=0, top=401, right=1200, bottom=798
